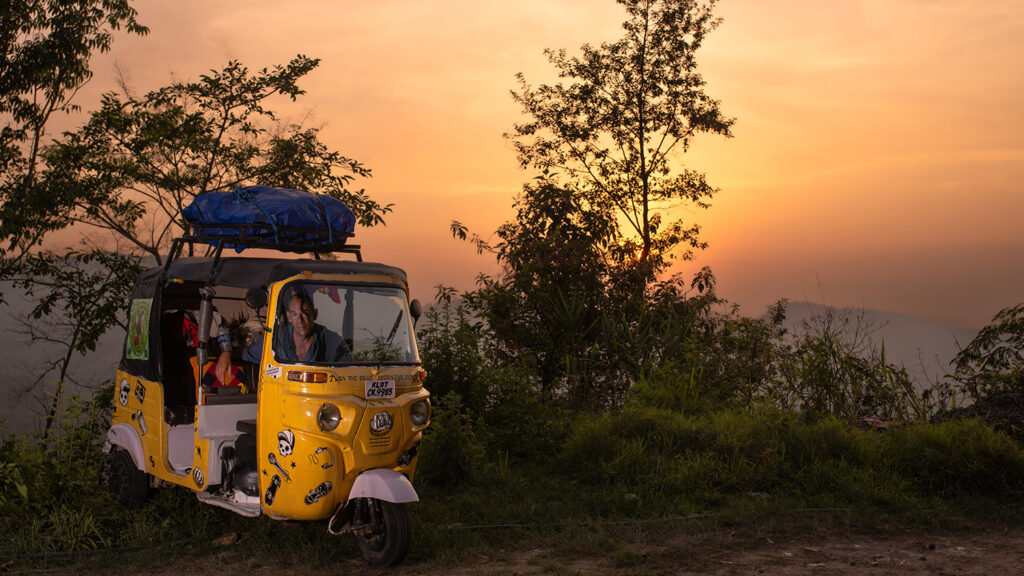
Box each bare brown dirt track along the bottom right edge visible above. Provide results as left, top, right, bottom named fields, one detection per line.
left=389, top=529, right=1024, bottom=576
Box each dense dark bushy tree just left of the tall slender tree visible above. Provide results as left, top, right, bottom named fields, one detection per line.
left=453, top=178, right=616, bottom=396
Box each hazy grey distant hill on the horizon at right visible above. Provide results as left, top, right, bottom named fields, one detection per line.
left=785, top=301, right=978, bottom=386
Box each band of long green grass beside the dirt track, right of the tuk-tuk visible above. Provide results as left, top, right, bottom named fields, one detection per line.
left=559, top=408, right=1024, bottom=511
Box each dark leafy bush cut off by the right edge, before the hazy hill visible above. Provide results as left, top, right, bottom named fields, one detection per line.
left=952, top=304, right=1024, bottom=400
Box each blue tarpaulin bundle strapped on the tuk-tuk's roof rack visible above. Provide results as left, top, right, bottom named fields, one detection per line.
left=181, top=186, right=355, bottom=252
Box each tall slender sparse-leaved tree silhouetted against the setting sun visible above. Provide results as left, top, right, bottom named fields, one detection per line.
left=507, top=0, right=733, bottom=281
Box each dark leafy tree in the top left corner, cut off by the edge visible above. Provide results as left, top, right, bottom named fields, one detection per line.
left=0, top=0, right=148, bottom=255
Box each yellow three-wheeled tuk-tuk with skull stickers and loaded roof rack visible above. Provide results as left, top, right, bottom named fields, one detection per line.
left=108, top=187, right=430, bottom=566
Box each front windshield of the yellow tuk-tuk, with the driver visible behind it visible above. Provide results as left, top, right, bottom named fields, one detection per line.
left=273, top=282, right=420, bottom=364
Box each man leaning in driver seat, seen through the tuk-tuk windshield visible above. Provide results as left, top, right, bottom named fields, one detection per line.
left=273, top=290, right=352, bottom=362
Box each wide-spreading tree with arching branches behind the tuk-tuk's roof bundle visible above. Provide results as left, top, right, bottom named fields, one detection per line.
left=0, top=51, right=390, bottom=427
